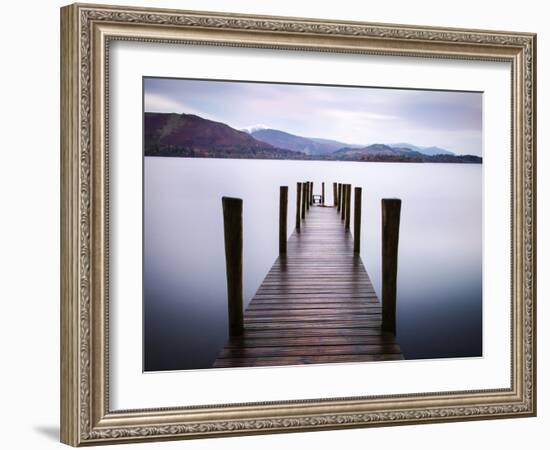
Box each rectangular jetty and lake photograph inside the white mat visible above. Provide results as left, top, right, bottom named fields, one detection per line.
left=142, top=76, right=484, bottom=372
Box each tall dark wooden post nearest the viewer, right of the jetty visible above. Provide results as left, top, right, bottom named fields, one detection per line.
left=382, top=198, right=401, bottom=334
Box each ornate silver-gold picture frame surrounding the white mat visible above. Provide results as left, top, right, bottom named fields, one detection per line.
left=61, top=4, right=536, bottom=446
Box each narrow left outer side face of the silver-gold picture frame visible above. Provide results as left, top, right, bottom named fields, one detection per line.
left=60, top=5, right=80, bottom=446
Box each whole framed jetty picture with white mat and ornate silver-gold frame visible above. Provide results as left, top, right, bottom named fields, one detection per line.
left=61, top=4, right=536, bottom=446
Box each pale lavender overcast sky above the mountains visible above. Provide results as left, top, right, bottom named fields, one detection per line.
left=144, top=78, right=482, bottom=155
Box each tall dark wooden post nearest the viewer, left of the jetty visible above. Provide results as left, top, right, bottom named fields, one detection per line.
left=222, top=197, right=243, bottom=336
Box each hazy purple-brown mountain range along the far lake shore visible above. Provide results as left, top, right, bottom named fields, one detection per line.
left=144, top=112, right=481, bottom=163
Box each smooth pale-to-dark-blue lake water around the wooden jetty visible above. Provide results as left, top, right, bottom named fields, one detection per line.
left=143, top=157, right=482, bottom=371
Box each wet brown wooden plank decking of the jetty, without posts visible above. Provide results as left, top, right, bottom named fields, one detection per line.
left=214, top=206, right=403, bottom=367
